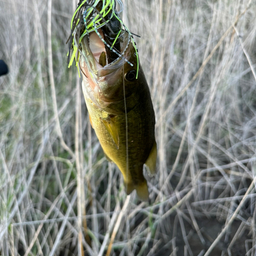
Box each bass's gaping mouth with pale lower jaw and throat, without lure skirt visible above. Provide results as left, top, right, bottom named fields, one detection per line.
left=79, top=29, right=134, bottom=105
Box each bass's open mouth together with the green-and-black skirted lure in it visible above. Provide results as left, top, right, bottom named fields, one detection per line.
left=69, top=0, right=138, bottom=77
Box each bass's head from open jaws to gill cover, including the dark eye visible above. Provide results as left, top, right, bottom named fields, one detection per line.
left=79, top=29, right=138, bottom=108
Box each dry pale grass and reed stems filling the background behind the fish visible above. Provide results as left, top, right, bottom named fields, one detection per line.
left=0, top=0, right=256, bottom=256
